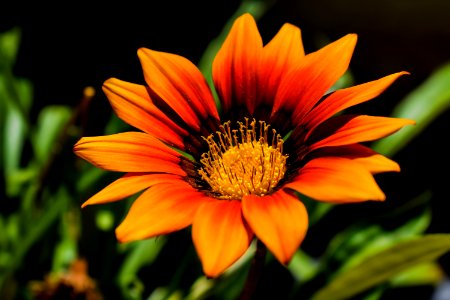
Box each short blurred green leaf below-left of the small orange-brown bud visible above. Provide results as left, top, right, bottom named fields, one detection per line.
left=33, top=105, right=72, bottom=164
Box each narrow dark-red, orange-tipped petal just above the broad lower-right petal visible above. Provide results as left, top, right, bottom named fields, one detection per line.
left=314, top=144, right=400, bottom=174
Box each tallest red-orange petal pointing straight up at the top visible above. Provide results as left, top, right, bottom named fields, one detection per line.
left=212, top=13, right=263, bottom=113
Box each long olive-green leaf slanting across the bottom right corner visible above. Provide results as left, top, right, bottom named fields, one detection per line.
left=312, top=234, right=450, bottom=300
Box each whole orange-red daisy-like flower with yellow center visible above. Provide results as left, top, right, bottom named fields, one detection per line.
left=74, top=13, right=414, bottom=277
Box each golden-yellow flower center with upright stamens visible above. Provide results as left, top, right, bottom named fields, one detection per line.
left=198, top=119, right=287, bottom=199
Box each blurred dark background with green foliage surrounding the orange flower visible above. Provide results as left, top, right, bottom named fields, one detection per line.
left=0, top=0, right=450, bottom=300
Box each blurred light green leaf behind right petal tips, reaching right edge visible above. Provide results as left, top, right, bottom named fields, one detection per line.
left=372, top=63, right=450, bottom=156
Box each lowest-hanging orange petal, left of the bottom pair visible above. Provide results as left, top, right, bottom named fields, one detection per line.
left=192, top=200, right=253, bottom=277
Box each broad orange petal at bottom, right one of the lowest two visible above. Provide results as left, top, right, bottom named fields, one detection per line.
left=242, top=190, right=308, bottom=264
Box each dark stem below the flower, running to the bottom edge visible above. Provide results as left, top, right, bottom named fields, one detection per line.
left=239, top=240, right=267, bottom=300
